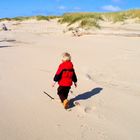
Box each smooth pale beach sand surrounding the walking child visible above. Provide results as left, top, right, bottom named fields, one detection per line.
left=0, top=21, right=140, bottom=140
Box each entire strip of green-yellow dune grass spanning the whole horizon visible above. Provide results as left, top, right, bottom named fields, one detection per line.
left=0, top=9, right=140, bottom=29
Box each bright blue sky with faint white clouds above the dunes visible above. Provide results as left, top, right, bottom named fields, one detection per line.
left=0, top=0, right=140, bottom=18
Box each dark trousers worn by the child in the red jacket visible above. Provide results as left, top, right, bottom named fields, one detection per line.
left=57, top=86, right=71, bottom=103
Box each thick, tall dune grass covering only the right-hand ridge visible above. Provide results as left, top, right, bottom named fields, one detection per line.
left=59, top=10, right=140, bottom=28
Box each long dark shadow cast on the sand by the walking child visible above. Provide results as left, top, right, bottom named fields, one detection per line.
left=69, top=87, right=103, bottom=108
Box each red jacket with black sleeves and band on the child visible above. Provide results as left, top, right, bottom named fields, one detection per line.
left=54, top=61, right=77, bottom=87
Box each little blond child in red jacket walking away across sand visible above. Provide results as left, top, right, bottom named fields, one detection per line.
left=52, top=53, right=77, bottom=109
